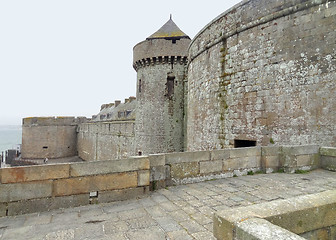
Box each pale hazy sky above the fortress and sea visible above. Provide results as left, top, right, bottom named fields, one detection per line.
left=0, top=0, right=240, bottom=124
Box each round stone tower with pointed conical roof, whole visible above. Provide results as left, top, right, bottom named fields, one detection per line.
left=133, top=18, right=190, bottom=155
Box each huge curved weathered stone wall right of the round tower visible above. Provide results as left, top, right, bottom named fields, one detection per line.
left=187, top=0, right=336, bottom=151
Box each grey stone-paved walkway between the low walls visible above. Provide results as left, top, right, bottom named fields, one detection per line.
left=0, top=170, right=336, bottom=240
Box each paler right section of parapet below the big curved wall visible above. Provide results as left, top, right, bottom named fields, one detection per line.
left=149, top=145, right=320, bottom=188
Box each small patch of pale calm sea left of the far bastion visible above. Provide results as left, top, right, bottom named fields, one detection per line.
left=0, top=125, right=22, bottom=153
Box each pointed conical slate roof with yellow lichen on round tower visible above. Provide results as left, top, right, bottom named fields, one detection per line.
left=147, top=16, right=190, bottom=40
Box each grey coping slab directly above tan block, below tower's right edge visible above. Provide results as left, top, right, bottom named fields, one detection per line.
left=166, top=151, right=210, bottom=164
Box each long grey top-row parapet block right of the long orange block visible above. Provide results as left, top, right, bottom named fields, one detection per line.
left=70, top=157, right=149, bottom=177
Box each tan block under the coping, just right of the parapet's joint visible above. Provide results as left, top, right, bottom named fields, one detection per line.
left=170, top=162, right=199, bottom=179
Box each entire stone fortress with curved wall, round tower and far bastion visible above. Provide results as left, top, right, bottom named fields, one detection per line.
left=22, top=0, right=336, bottom=161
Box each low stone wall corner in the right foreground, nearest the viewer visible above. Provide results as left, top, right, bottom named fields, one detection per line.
left=213, top=190, right=336, bottom=240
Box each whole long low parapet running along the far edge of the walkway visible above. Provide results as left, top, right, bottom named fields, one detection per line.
left=0, top=145, right=335, bottom=216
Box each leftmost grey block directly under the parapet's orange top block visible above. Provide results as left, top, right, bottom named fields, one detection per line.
left=0, top=180, right=52, bottom=202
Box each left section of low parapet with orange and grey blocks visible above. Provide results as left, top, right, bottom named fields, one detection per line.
left=0, top=157, right=149, bottom=216
